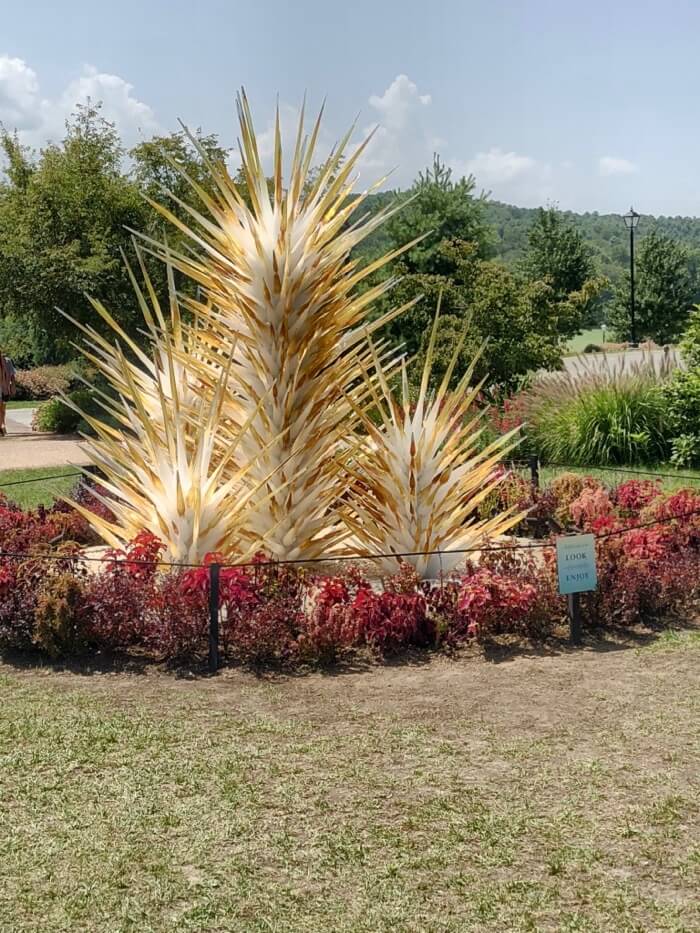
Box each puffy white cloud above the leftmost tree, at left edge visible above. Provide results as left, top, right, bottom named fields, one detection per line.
left=0, top=55, right=162, bottom=146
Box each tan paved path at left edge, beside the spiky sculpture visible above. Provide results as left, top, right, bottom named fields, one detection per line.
left=0, top=408, right=90, bottom=470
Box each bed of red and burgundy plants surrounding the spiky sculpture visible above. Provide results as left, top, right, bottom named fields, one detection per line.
left=0, top=474, right=700, bottom=667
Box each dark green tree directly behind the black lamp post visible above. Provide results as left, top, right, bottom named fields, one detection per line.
left=610, top=229, right=698, bottom=344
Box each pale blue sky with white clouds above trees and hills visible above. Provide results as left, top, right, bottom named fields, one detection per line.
left=0, top=0, right=700, bottom=216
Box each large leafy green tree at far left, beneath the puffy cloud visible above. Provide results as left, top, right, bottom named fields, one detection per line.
left=0, top=103, right=150, bottom=363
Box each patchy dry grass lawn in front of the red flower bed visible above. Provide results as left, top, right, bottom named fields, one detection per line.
left=0, top=632, right=700, bottom=933
